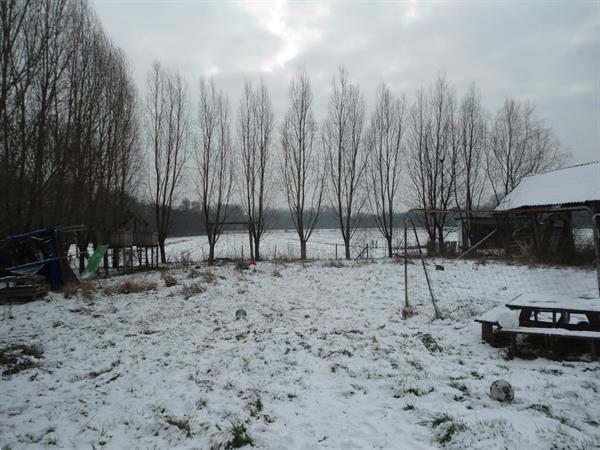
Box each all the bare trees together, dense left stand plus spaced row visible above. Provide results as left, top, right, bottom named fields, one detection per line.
left=0, top=0, right=568, bottom=262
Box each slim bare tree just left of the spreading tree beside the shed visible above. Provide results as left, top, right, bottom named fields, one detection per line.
left=454, top=83, right=487, bottom=243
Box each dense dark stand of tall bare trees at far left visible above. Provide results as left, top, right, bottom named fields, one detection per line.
left=0, top=0, right=140, bottom=246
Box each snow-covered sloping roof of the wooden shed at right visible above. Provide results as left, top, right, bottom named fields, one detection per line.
left=496, top=161, right=600, bottom=211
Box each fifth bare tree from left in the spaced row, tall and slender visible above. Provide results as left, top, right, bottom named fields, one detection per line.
left=322, top=67, right=367, bottom=259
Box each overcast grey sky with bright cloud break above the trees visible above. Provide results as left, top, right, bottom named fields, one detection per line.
left=93, top=0, right=600, bottom=162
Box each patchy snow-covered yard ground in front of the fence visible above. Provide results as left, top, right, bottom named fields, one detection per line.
left=0, top=260, right=600, bottom=449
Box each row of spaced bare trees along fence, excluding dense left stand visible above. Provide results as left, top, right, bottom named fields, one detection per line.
left=145, top=64, right=567, bottom=261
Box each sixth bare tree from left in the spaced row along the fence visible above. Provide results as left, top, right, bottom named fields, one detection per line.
left=367, top=83, right=406, bottom=257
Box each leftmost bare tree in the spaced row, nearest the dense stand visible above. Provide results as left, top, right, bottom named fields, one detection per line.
left=146, top=63, right=189, bottom=263
